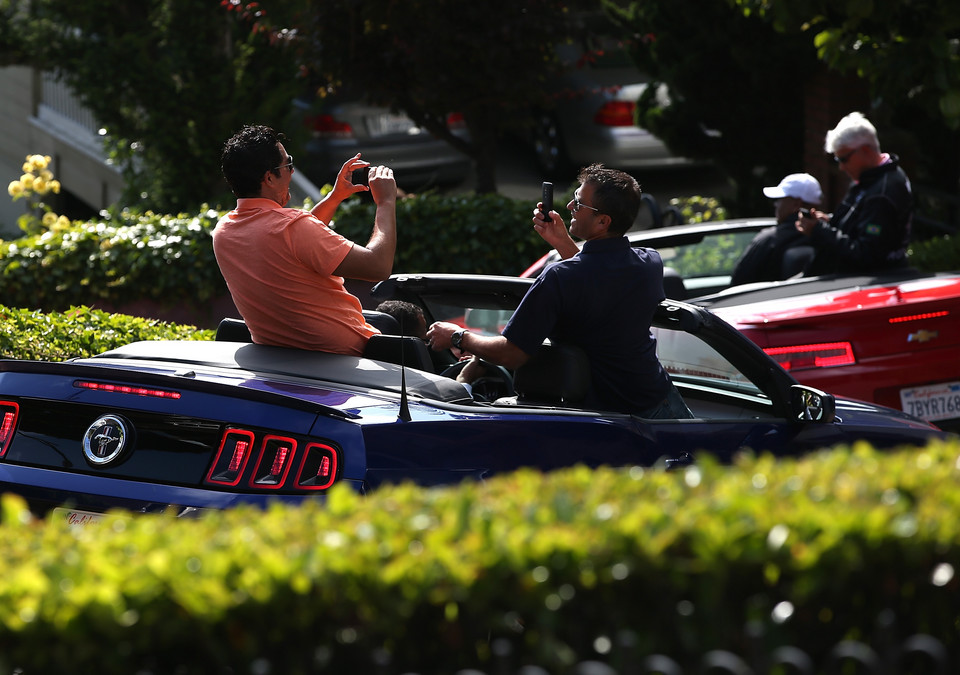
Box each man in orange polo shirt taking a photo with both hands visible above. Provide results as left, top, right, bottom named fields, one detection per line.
left=213, top=125, right=397, bottom=356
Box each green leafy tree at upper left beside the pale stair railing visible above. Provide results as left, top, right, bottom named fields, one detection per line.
left=0, top=0, right=299, bottom=212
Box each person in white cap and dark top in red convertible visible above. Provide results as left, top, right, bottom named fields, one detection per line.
left=730, top=173, right=823, bottom=286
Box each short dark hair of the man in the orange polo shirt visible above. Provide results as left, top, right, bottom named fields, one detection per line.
left=220, top=124, right=283, bottom=199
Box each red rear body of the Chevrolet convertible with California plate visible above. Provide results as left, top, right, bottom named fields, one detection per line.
left=694, top=269, right=960, bottom=430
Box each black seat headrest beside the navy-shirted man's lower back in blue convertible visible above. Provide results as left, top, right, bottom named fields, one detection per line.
left=513, top=342, right=591, bottom=406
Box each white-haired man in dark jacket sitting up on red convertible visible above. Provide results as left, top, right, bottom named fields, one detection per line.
left=797, top=112, right=913, bottom=275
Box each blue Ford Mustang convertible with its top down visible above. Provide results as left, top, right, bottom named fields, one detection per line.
left=0, top=275, right=943, bottom=521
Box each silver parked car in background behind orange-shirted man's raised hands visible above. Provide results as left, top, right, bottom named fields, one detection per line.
left=294, top=97, right=471, bottom=189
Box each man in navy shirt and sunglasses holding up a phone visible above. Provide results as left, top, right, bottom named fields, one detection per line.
left=427, top=164, right=692, bottom=418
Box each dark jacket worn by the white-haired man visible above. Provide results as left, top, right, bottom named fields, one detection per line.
left=807, top=155, right=913, bottom=275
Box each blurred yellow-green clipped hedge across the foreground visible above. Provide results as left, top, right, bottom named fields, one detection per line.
left=0, top=443, right=960, bottom=675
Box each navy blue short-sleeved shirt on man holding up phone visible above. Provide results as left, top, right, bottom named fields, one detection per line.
left=503, top=237, right=669, bottom=413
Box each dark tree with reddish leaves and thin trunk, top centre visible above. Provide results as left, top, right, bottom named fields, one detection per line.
left=223, top=0, right=592, bottom=192
